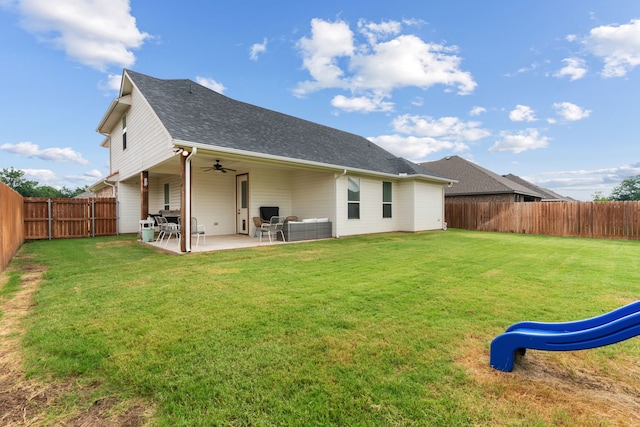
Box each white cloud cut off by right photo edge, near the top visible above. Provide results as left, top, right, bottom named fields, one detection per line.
left=584, top=19, right=640, bottom=77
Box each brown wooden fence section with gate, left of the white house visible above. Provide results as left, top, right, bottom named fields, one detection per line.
left=24, top=197, right=118, bottom=240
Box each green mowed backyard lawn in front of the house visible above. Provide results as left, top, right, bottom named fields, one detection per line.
left=5, top=230, right=640, bottom=426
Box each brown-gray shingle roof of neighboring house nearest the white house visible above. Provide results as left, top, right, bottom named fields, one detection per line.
left=421, top=156, right=544, bottom=198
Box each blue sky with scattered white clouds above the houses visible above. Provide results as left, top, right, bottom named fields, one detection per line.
left=0, top=0, right=640, bottom=200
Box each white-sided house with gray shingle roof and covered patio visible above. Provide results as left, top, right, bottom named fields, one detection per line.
left=91, top=70, right=452, bottom=252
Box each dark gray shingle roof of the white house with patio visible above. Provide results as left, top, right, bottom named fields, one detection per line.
left=125, top=70, right=447, bottom=180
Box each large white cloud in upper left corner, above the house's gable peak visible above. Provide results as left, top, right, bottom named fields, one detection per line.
left=18, top=0, right=150, bottom=71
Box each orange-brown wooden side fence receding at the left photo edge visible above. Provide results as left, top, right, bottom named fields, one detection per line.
left=0, top=182, right=24, bottom=273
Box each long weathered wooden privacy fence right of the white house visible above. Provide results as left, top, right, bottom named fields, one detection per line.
left=445, top=201, right=640, bottom=239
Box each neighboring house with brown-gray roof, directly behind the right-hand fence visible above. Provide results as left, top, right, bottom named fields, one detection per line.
left=421, top=156, right=561, bottom=203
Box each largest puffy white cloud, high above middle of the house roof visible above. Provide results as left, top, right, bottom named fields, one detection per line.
left=294, top=19, right=477, bottom=111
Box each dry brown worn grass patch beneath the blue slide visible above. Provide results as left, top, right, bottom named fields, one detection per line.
left=458, top=337, right=640, bottom=426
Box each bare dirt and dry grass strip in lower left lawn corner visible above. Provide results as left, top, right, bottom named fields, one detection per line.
left=0, top=255, right=153, bottom=427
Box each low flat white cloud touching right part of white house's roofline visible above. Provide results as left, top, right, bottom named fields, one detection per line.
left=368, top=134, right=469, bottom=161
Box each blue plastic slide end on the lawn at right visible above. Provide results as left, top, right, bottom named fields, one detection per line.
left=489, top=301, right=640, bottom=372
